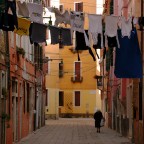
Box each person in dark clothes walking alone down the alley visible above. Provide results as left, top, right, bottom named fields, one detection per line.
left=94, top=110, right=103, bottom=133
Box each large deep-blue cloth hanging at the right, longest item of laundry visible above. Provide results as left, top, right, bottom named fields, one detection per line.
left=114, top=29, right=143, bottom=78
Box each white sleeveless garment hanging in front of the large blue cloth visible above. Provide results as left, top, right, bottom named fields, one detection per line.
left=121, top=17, right=132, bottom=38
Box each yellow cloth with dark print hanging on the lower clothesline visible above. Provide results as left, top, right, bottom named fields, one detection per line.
left=14, top=18, right=31, bottom=35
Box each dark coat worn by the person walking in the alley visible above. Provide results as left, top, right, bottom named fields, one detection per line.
left=94, top=111, right=103, bottom=128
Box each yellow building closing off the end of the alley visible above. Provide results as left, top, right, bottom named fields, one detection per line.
left=45, top=0, right=102, bottom=118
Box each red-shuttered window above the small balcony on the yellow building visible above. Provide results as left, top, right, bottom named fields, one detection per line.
left=74, top=61, right=81, bottom=81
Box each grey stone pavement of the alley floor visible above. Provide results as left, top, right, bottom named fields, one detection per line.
left=18, top=118, right=130, bottom=144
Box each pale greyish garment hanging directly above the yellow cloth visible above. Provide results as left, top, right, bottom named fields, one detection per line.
left=17, top=1, right=29, bottom=18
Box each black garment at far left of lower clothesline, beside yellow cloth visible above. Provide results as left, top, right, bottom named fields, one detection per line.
left=0, top=13, right=15, bottom=31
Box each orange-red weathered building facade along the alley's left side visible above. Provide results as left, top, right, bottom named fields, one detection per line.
left=0, top=0, right=46, bottom=144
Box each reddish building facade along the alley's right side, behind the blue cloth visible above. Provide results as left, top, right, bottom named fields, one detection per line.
left=101, top=0, right=144, bottom=144
